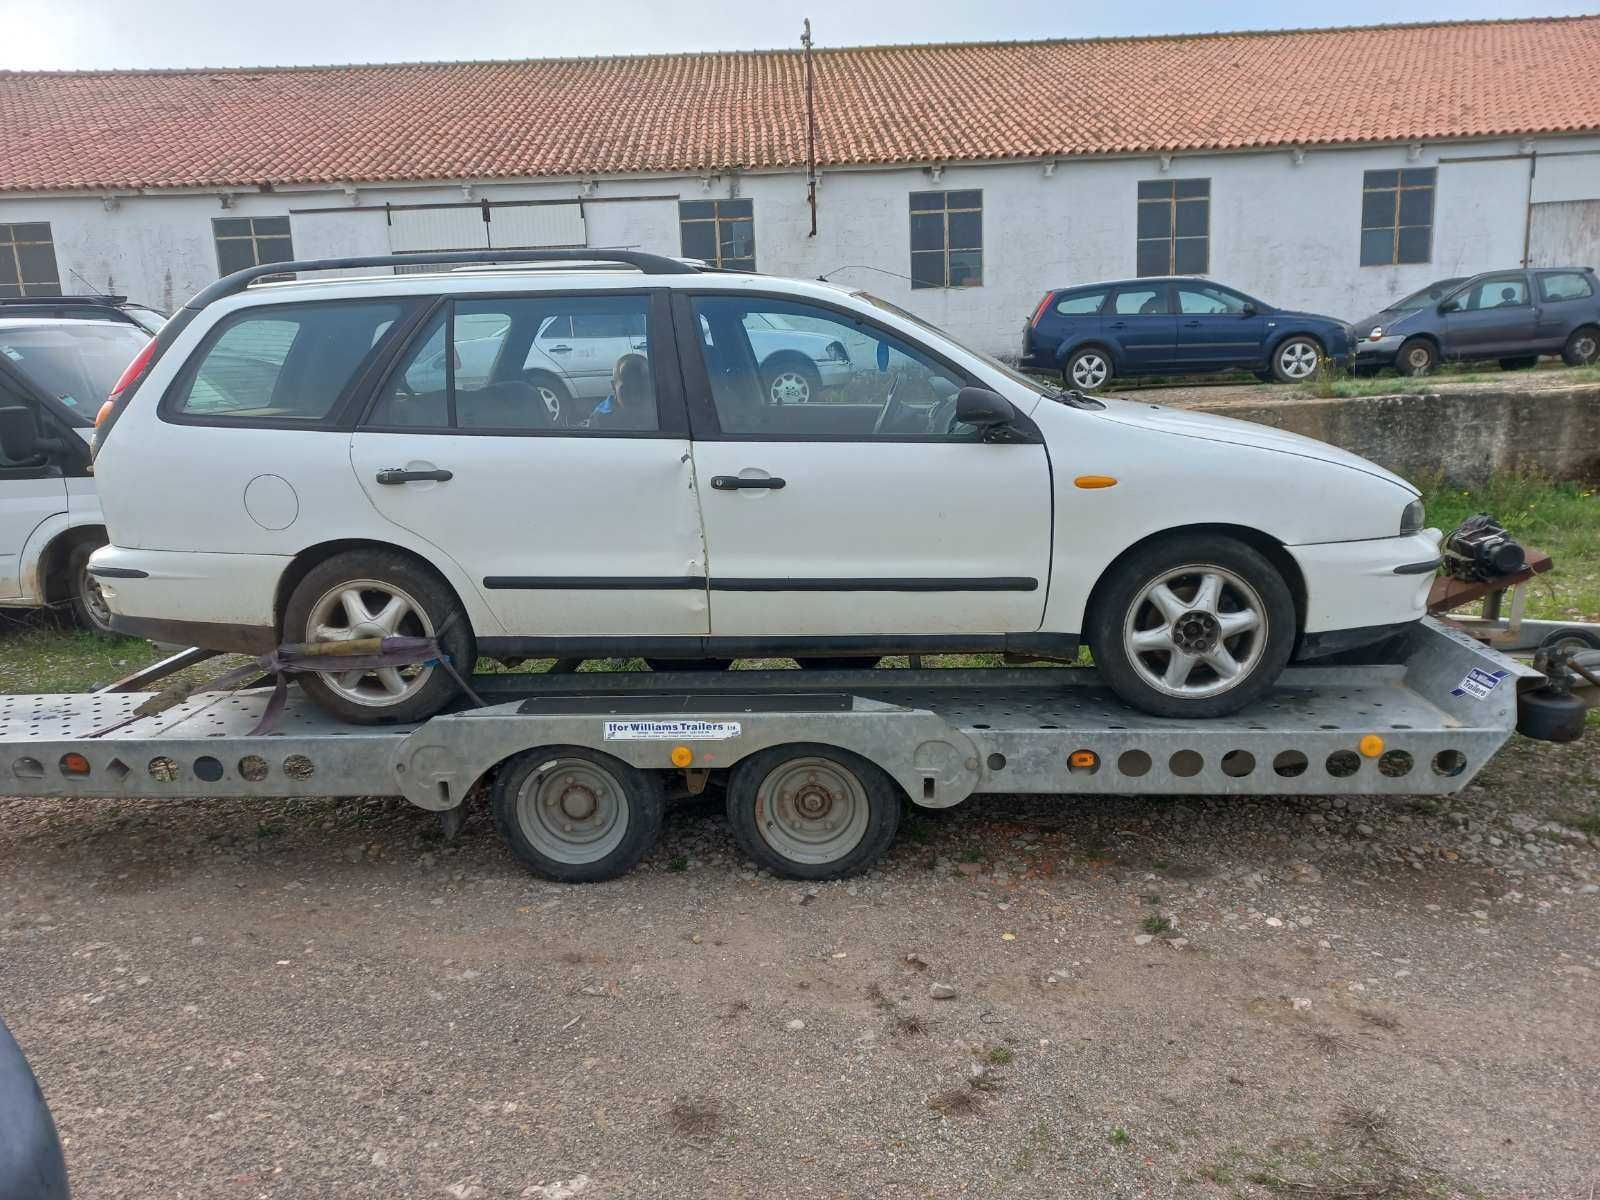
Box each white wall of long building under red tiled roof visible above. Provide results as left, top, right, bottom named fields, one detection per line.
left=0, top=138, right=1600, bottom=355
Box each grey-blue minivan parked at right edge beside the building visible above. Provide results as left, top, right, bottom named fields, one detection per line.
left=1350, top=267, right=1600, bottom=374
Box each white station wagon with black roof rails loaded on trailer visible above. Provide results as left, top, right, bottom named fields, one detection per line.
left=81, top=251, right=1438, bottom=722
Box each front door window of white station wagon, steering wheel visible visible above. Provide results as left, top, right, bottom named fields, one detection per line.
left=691, top=296, right=978, bottom=440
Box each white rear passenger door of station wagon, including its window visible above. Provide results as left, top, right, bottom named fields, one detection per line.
left=350, top=291, right=709, bottom=653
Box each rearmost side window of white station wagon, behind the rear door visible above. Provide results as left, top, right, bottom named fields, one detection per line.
left=168, top=301, right=405, bottom=422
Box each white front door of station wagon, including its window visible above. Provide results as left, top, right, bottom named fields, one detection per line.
left=674, top=291, right=1051, bottom=653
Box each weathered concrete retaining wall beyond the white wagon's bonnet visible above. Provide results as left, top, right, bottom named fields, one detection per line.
left=1192, top=386, right=1600, bottom=486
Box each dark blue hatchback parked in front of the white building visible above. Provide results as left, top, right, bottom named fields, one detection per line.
left=1022, top=277, right=1349, bottom=392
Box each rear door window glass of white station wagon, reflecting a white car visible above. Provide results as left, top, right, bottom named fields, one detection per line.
left=366, top=294, right=661, bottom=434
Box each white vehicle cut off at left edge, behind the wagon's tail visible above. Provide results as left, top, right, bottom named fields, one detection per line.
left=0, top=299, right=150, bottom=632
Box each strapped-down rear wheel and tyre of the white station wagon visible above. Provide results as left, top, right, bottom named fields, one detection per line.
left=283, top=550, right=477, bottom=725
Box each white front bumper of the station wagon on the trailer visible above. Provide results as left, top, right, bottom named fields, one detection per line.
left=1286, top=530, right=1442, bottom=634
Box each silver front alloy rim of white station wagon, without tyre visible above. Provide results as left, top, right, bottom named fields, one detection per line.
left=1122, top=563, right=1267, bottom=699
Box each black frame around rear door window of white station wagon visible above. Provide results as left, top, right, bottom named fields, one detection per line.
left=349, top=286, right=690, bottom=442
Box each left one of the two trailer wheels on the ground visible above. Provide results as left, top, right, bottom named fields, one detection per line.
left=490, top=746, right=664, bottom=883
